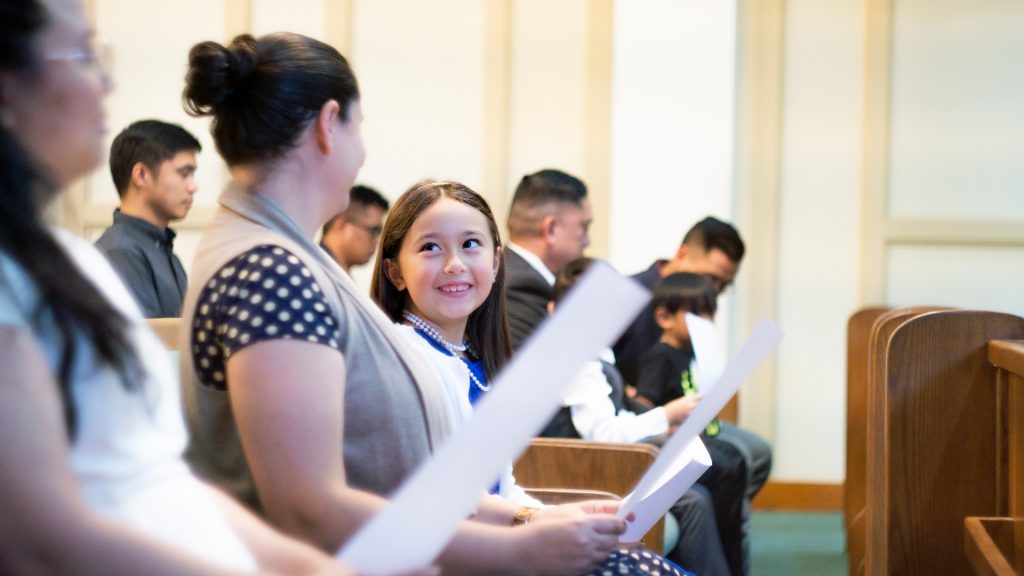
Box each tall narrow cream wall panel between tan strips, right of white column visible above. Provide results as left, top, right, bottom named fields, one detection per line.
left=773, top=0, right=864, bottom=482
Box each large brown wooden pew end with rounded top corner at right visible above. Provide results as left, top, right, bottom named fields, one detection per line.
left=865, top=311, right=1024, bottom=576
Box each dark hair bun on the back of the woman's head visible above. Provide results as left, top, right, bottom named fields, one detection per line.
left=182, top=34, right=257, bottom=116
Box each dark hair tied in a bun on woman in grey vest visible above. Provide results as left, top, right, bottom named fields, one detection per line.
left=182, top=32, right=359, bottom=166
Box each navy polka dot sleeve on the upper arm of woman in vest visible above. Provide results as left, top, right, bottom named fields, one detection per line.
left=191, top=246, right=339, bottom=389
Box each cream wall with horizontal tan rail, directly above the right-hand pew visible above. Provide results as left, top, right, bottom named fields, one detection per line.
left=880, top=0, right=1024, bottom=323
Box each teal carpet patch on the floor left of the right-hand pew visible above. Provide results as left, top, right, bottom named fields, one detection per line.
left=750, top=511, right=847, bottom=576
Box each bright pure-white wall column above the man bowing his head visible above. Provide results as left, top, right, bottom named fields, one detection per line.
left=606, top=0, right=736, bottom=274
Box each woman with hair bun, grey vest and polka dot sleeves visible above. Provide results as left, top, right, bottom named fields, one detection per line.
left=181, top=33, right=643, bottom=575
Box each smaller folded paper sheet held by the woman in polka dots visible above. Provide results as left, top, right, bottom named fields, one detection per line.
left=618, top=320, right=782, bottom=542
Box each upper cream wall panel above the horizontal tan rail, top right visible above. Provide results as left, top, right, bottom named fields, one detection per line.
left=888, top=0, right=1024, bottom=220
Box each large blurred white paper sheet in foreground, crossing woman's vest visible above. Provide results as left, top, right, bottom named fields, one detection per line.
left=338, top=262, right=649, bottom=575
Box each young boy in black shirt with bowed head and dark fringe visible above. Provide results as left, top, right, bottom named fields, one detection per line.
left=637, top=273, right=748, bottom=575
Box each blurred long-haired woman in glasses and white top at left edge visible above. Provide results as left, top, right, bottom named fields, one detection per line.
left=0, top=0, right=362, bottom=575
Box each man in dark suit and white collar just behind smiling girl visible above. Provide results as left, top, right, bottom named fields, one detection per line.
left=505, top=169, right=592, bottom=348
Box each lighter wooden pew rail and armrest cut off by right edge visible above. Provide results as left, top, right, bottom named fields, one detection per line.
left=964, top=340, right=1024, bottom=576
